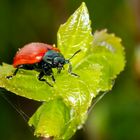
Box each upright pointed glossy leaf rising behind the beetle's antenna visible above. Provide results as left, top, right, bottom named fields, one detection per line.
left=57, top=2, right=93, bottom=64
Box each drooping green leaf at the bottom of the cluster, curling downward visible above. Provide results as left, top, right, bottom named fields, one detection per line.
left=29, top=99, right=70, bottom=139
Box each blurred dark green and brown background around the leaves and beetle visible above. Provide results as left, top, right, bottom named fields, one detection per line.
left=0, top=0, right=140, bottom=140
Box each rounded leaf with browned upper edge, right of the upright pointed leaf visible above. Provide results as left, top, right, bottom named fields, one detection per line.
left=90, top=30, right=125, bottom=91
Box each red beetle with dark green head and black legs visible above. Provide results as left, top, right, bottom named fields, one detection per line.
left=7, top=43, right=80, bottom=86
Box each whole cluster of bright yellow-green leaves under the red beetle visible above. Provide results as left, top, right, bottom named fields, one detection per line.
left=0, top=3, right=125, bottom=140
